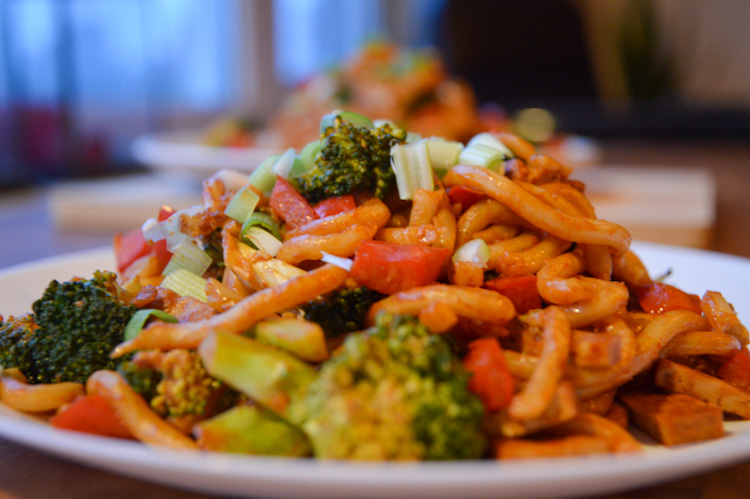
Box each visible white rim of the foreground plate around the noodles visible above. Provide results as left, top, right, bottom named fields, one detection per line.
left=0, top=243, right=750, bottom=497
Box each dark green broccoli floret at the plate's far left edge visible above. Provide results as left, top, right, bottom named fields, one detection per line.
left=0, top=272, right=137, bottom=384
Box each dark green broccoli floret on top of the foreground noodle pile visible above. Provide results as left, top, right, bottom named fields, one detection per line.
left=296, top=116, right=406, bottom=203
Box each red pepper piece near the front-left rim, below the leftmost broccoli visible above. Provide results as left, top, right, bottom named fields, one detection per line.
left=49, top=395, right=133, bottom=438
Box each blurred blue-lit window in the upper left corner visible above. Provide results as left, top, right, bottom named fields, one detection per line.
left=0, top=0, right=240, bottom=186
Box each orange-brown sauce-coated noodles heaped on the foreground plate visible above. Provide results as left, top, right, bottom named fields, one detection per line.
left=2, top=130, right=750, bottom=458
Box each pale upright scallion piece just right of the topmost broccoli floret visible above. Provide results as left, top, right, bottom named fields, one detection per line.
left=391, top=140, right=435, bottom=199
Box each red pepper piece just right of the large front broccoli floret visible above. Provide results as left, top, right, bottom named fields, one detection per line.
left=462, top=338, right=514, bottom=412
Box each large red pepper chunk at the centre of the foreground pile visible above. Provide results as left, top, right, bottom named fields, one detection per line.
left=349, top=241, right=451, bottom=294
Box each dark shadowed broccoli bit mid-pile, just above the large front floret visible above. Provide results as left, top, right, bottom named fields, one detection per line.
left=301, top=286, right=385, bottom=337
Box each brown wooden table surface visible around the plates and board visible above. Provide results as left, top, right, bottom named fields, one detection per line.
left=0, top=141, right=750, bottom=499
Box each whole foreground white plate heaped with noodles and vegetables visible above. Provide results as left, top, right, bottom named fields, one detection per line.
left=0, top=113, right=750, bottom=497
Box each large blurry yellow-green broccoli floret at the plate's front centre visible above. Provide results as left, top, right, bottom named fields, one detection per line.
left=303, top=313, right=486, bottom=460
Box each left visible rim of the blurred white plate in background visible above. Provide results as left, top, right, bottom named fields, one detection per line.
left=130, top=130, right=279, bottom=181
